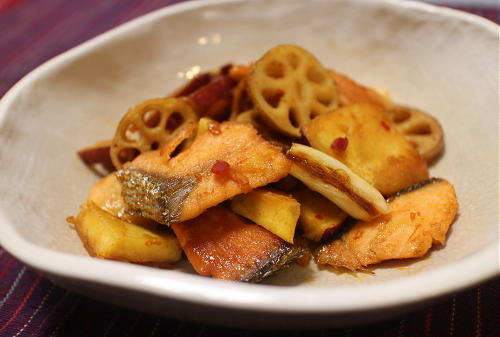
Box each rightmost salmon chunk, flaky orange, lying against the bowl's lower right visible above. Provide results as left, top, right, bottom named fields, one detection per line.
left=315, top=178, right=458, bottom=270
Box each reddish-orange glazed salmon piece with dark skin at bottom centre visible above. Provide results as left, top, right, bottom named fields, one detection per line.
left=172, top=206, right=304, bottom=282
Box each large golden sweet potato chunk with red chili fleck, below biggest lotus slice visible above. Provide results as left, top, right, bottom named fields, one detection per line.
left=304, top=103, right=429, bottom=196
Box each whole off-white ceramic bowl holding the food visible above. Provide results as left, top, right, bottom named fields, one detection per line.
left=0, top=0, right=498, bottom=328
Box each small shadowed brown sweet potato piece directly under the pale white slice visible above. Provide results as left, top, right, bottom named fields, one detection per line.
left=293, top=188, right=347, bottom=241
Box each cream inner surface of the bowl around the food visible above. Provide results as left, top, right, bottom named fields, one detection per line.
left=0, top=0, right=498, bottom=304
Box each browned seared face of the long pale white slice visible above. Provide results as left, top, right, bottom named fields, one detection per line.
left=287, top=153, right=379, bottom=216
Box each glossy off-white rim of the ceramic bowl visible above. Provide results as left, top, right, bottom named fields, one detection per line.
left=0, top=0, right=500, bottom=314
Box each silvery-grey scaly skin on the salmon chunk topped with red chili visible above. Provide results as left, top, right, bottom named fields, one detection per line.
left=116, top=168, right=197, bottom=225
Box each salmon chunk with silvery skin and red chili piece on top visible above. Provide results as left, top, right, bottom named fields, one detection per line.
left=117, top=122, right=291, bottom=224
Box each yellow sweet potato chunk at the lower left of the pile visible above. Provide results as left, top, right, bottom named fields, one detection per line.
left=73, top=202, right=182, bottom=264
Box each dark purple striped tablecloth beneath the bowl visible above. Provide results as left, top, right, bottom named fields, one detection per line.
left=0, top=0, right=500, bottom=337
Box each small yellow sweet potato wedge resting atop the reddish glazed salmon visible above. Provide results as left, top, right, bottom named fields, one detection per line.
left=231, top=189, right=300, bottom=243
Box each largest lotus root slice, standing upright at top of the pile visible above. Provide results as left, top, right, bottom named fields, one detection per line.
left=248, top=45, right=339, bottom=137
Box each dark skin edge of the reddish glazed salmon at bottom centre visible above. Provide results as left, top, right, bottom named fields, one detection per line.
left=240, top=243, right=305, bottom=283
